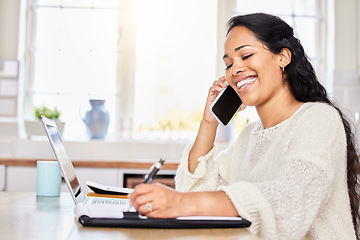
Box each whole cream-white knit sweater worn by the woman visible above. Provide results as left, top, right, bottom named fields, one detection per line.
left=175, top=103, right=355, bottom=240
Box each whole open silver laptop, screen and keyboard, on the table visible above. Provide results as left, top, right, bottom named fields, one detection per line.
left=41, top=116, right=134, bottom=217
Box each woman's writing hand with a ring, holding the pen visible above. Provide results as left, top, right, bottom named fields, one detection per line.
left=128, top=183, right=186, bottom=218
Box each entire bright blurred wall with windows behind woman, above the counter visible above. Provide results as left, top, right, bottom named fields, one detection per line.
left=0, top=0, right=360, bottom=150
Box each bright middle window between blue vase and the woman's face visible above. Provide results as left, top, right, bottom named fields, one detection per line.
left=134, top=0, right=217, bottom=138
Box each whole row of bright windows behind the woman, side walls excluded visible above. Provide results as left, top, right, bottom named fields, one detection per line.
left=24, top=0, right=325, bottom=140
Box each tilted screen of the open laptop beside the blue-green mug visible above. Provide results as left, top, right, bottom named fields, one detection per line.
left=42, top=117, right=85, bottom=203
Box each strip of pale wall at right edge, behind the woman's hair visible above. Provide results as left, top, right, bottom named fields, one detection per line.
left=333, top=0, right=360, bottom=142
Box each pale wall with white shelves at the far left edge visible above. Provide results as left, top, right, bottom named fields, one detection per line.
left=0, top=0, right=19, bottom=157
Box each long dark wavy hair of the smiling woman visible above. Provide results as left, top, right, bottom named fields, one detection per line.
left=227, top=13, right=360, bottom=236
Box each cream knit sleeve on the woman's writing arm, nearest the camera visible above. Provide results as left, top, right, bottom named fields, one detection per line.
left=219, top=104, right=346, bottom=239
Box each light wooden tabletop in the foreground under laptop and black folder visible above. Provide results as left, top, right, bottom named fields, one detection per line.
left=0, top=192, right=259, bottom=240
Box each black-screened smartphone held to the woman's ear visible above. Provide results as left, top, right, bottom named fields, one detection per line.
left=210, top=85, right=242, bottom=126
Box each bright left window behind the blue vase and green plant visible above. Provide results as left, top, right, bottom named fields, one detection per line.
left=25, top=0, right=121, bottom=139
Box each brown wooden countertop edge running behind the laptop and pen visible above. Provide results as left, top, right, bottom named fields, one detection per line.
left=0, top=158, right=178, bottom=170
